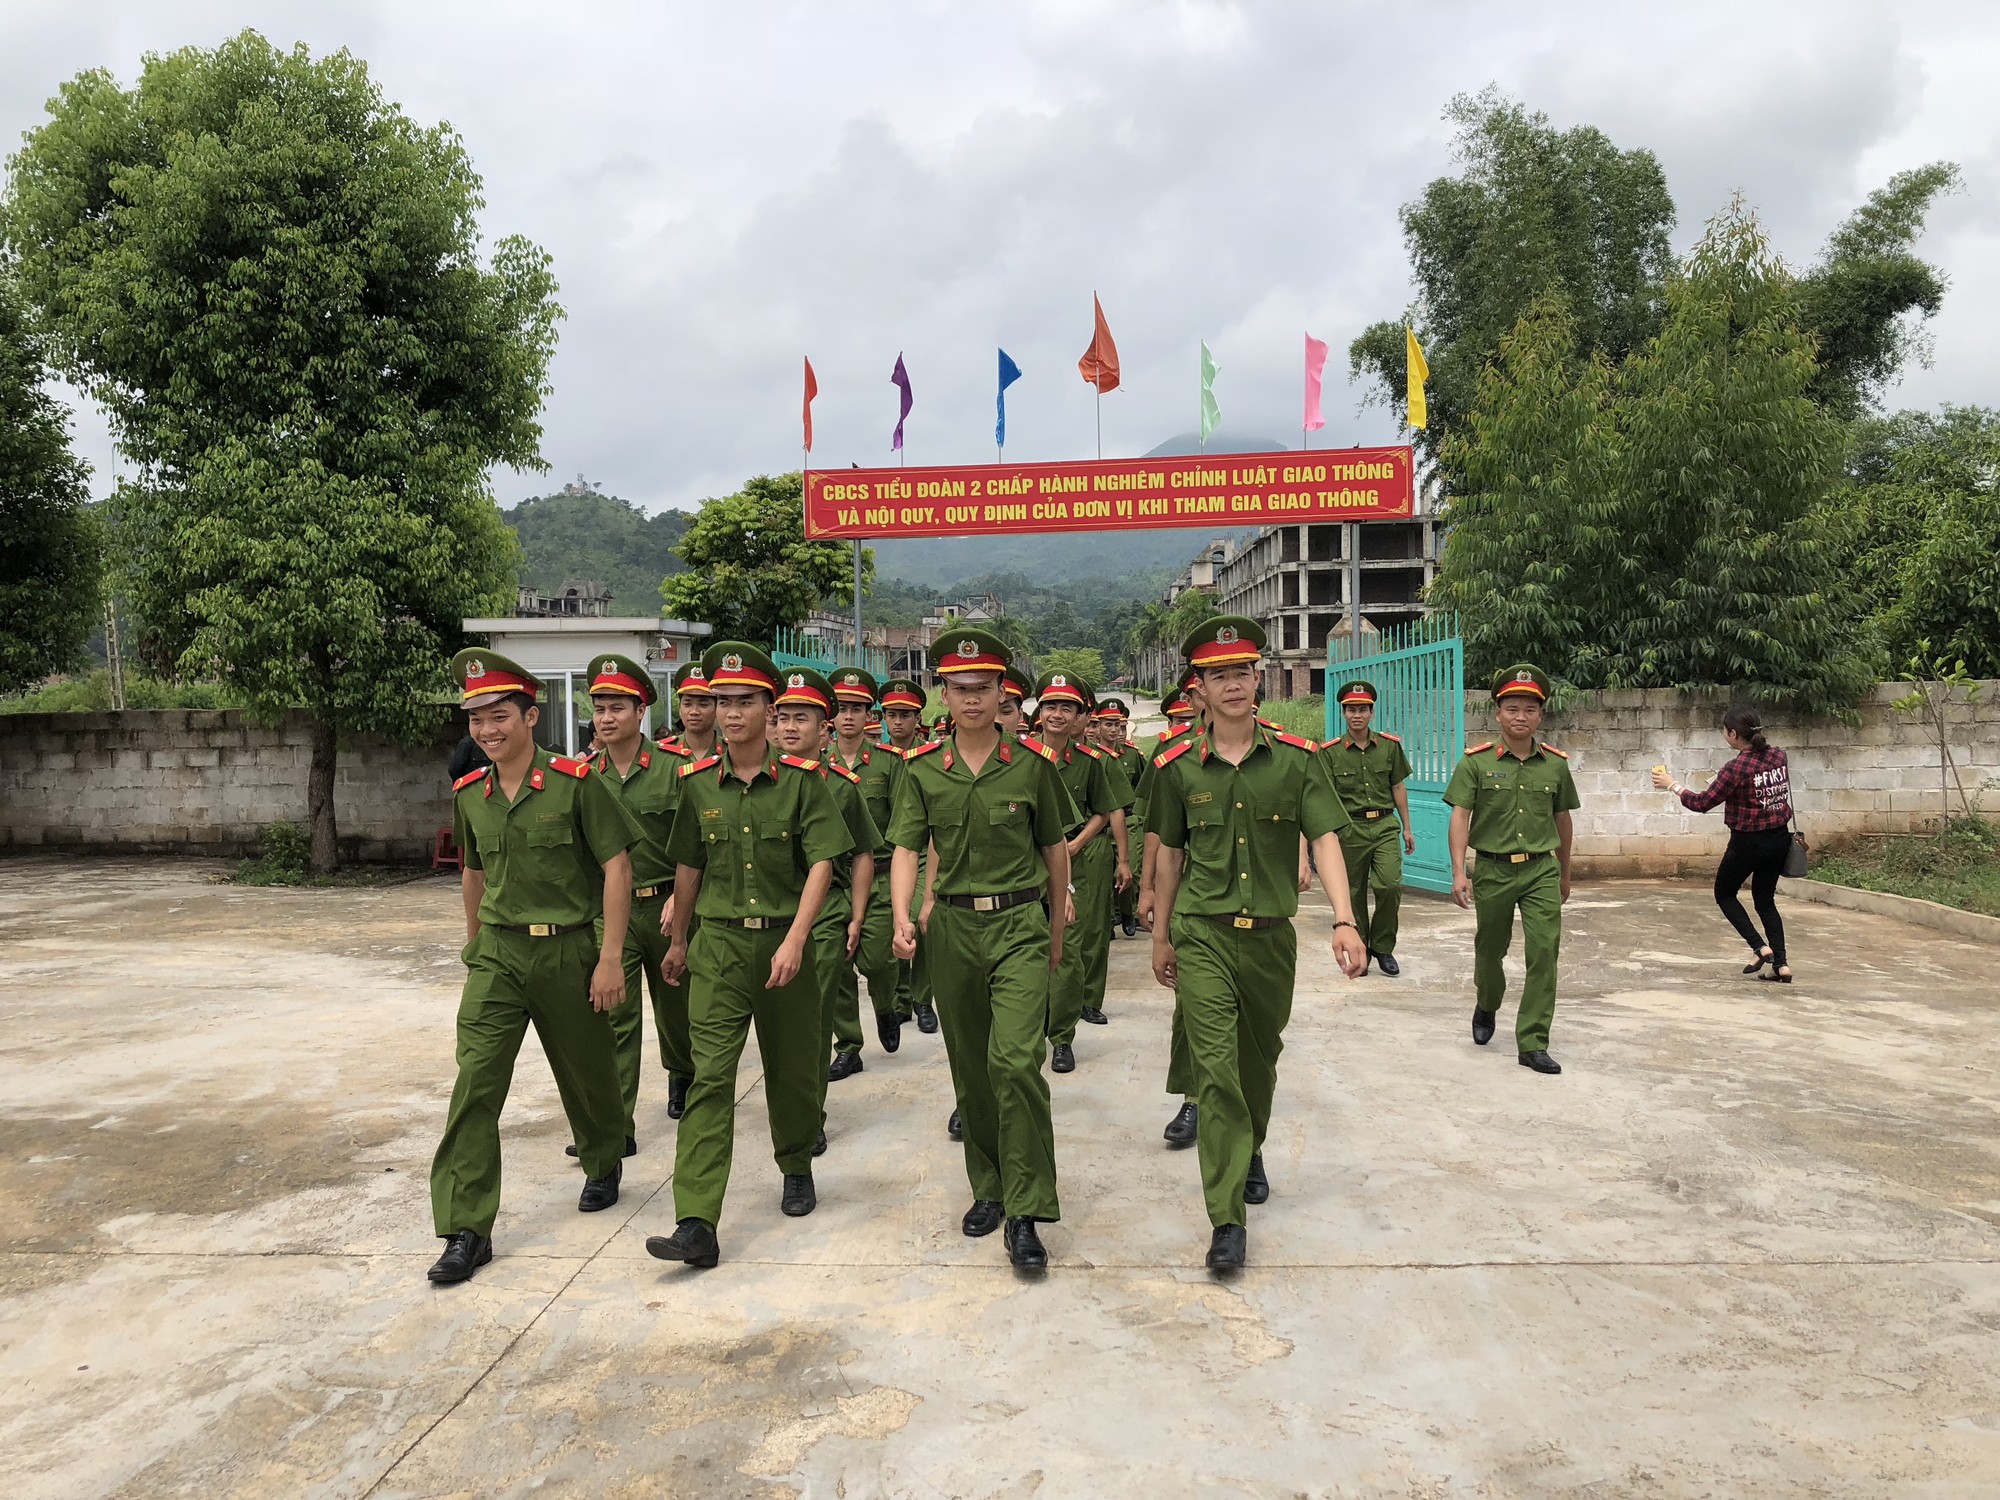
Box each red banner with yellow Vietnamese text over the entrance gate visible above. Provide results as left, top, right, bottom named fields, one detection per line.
left=806, top=448, right=1414, bottom=536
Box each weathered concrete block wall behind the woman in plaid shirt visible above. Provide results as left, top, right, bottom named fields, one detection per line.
left=1464, top=682, right=2000, bottom=876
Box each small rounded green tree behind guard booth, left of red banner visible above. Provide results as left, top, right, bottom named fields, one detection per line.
left=660, top=470, right=874, bottom=642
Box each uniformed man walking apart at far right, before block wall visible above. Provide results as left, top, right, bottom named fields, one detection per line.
left=1444, top=662, right=1580, bottom=1074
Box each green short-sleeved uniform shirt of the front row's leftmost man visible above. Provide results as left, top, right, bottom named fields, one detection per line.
left=452, top=748, right=646, bottom=926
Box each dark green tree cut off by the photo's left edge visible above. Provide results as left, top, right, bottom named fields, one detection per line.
left=0, top=272, right=98, bottom=692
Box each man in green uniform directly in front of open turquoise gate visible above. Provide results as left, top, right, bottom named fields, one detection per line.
left=1320, top=680, right=1416, bottom=978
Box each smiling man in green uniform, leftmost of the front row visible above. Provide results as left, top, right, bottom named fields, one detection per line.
left=430, top=648, right=644, bottom=1286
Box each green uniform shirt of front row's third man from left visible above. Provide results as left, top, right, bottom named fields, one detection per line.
left=888, top=734, right=1078, bottom=896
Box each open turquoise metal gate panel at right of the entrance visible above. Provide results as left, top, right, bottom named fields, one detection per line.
left=1326, top=614, right=1466, bottom=890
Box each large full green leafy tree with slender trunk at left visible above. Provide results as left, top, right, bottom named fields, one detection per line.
left=4, top=32, right=560, bottom=872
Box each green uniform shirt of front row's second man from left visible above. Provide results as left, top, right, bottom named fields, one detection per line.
left=666, top=748, right=854, bottom=920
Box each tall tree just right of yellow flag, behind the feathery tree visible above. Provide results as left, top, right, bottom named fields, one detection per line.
left=1348, top=88, right=1674, bottom=470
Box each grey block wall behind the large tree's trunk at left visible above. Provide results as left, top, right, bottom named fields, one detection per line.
left=0, top=710, right=462, bottom=860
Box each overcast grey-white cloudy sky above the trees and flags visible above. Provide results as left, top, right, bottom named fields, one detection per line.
left=0, top=0, right=2000, bottom=506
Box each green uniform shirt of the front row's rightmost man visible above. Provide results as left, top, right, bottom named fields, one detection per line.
left=1146, top=726, right=1348, bottom=916
